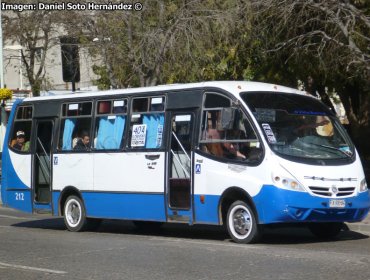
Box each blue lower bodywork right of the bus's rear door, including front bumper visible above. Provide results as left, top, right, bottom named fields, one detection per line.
left=49, top=185, right=370, bottom=224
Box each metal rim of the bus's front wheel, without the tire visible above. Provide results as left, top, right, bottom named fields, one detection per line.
left=229, top=205, right=253, bottom=239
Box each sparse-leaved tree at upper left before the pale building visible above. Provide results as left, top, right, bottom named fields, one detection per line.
left=2, top=0, right=83, bottom=96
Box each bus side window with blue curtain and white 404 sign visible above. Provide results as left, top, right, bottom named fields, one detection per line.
left=129, top=96, right=165, bottom=149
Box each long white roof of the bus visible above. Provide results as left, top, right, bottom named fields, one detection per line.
left=24, top=81, right=304, bottom=101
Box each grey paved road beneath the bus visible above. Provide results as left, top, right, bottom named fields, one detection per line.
left=0, top=207, right=370, bottom=280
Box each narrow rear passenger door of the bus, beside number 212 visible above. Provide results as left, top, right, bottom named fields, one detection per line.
left=32, top=120, right=54, bottom=213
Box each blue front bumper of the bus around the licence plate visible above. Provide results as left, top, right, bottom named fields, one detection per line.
left=253, top=185, right=370, bottom=224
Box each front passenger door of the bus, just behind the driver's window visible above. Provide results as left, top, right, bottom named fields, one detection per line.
left=166, top=112, right=195, bottom=224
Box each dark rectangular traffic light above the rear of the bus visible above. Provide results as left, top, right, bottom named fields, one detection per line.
left=60, top=37, right=80, bottom=83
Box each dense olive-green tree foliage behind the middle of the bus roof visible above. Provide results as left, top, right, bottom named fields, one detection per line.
left=83, top=0, right=246, bottom=87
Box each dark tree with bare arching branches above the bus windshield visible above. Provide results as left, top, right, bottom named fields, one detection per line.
left=253, top=0, right=370, bottom=154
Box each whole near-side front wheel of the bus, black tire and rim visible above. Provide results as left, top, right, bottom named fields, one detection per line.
left=226, top=200, right=261, bottom=244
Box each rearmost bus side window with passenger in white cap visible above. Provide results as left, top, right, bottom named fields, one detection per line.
left=9, top=106, right=33, bottom=153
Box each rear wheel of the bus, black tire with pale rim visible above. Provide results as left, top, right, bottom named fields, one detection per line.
left=63, top=195, right=87, bottom=232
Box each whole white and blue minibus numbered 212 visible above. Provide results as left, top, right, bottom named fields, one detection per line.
left=1, top=81, right=370, bottom=243
